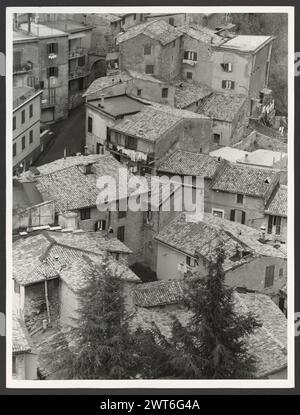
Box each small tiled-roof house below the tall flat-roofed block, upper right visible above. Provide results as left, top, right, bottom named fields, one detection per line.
left=197, top=92, right=249, bottom=148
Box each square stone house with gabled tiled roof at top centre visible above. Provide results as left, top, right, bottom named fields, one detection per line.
left=117, top=20, right=182, bottom=80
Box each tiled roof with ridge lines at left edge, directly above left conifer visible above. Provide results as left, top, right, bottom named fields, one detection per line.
left=13, top=231, right=136, bottom=285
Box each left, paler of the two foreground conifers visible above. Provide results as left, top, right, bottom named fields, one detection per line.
left=65, top=257, right=138, bottom=379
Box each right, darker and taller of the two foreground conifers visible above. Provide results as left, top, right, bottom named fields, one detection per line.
left=165, top=243, right=259, bottom=379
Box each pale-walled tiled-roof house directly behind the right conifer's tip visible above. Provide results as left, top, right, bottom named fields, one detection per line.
left=155, top=213, right=287, bottom=303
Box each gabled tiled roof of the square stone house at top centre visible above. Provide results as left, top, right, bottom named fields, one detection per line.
left=117, top=20, right=182, bottom=46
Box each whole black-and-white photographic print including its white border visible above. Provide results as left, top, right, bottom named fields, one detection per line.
left=6, top=4, right=294, bottom=388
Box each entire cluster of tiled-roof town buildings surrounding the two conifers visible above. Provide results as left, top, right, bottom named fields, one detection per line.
left=12, top=13, right=288, bottom=380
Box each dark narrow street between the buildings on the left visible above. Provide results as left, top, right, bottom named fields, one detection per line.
left=35, top=105, right=85, bottom=166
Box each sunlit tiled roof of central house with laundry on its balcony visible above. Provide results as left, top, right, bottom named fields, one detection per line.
left=112, top=107, right=182, bottom=141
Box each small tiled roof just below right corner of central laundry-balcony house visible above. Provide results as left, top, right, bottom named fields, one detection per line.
left=157, top=150, right=221, bottom=179
